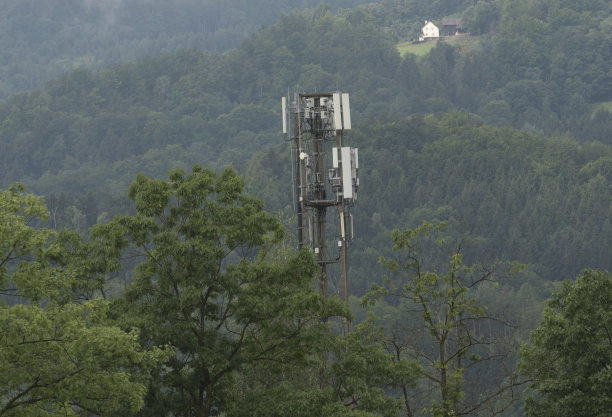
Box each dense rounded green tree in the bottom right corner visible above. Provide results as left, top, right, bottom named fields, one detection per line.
left=519, top=270, right=612, bottom=417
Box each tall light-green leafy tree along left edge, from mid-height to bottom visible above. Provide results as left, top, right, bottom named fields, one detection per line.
left=0, top=185, right=165, bottom=416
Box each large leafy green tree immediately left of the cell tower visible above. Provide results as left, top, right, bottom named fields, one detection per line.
left=92, top=166, right=345, bottom=416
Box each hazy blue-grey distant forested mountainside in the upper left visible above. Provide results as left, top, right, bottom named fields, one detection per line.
left=0, top=0, right=370, bottom=100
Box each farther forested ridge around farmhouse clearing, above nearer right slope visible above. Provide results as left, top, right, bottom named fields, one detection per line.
left=0, top=0, right=612, bottom=201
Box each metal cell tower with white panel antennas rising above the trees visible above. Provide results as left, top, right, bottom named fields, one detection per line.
left=282, top=92, right=359, bottom=333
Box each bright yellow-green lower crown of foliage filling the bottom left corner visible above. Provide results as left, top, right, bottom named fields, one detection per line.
left=0, top=300, right=164, bottom=416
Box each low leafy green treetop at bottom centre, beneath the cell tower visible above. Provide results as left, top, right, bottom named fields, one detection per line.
left=227, top=312, right=419, bottom=417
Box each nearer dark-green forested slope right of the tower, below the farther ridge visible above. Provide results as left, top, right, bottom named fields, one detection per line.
left=351, top=114, right=611, bottom=294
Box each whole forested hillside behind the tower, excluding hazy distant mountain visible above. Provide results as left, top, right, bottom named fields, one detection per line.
left=0, top=2, right=612, bottom=293
